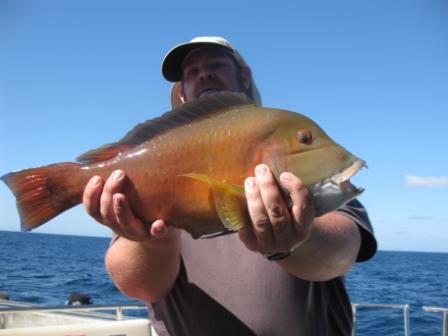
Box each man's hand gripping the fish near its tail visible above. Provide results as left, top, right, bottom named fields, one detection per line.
left=83, top=170, right=171, bottom=241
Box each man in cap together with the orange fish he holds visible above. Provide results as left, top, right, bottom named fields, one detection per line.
left=1, top=37, right=376, bottom=336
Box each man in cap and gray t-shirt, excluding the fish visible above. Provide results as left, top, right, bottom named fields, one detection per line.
left=84, top=37, right=376, bottom=336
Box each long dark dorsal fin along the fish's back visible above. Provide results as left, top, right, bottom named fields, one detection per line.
left=77, top=92, right=253, bottom=164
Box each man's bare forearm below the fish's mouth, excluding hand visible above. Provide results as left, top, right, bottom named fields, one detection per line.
left=278, top=212, right=361, bottom=281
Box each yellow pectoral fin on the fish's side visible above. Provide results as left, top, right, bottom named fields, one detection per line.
left=181, top=173, right=250, bottom=231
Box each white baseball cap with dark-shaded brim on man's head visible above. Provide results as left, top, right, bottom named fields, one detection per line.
left=162, top=36, right=261, bottom=105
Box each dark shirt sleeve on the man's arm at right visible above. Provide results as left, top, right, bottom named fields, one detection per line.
left=336, top=199, right=377, bottom=261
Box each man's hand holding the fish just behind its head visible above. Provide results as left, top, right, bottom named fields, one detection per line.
left=239, top=164, right=314, bottom=253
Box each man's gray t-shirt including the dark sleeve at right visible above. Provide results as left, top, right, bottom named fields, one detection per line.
left=148, top=200, right=376, bottom=336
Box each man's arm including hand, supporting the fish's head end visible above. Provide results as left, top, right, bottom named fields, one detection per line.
left=239, top=165, right=361, bottom=281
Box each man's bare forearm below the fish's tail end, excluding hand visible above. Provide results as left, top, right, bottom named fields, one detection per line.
left=106, top=230, right=180, bottom=302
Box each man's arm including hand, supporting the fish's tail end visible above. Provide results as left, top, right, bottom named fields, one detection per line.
left=83, top=171, right=180, bottom=302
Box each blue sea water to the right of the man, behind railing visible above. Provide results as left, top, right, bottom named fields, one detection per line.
left=347, top=251, right=448, bottom=336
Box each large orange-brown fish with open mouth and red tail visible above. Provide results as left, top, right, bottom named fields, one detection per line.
left=0, top=92, right=365, bottom=238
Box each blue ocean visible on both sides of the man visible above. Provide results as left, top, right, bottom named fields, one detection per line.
left=0, top=231, right=448, bottom=336
